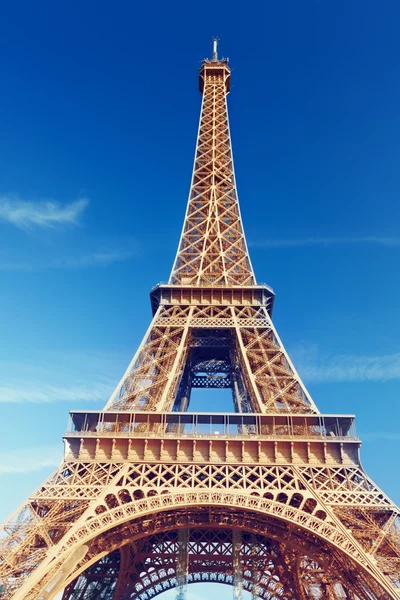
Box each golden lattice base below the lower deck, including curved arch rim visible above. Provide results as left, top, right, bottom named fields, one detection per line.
left=0, top=462, right=400, bottom=599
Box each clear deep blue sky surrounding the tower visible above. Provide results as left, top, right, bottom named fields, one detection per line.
left=0, top=0, right=400, bottom=596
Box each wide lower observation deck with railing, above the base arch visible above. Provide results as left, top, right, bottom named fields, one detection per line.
left=64, top=411, right=361, bottom=466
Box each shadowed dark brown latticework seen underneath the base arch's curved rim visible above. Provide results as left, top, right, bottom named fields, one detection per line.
left=63, top=525, right=394, bottom=600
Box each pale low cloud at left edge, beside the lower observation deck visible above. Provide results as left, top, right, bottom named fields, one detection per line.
left=0, top=444, right=63, bottom=475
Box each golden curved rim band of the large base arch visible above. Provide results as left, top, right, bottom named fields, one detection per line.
left=15, top=488, right=395, bottom=600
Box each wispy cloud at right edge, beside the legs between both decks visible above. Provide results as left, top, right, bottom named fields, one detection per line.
left=291, top=344, right=400, bottom=383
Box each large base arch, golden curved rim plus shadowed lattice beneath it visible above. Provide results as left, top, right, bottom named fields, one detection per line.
left=16, top=492, right=395, bottom=600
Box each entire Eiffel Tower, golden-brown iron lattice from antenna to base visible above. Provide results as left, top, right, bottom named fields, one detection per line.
left=0, top=41, right=400, bottom=600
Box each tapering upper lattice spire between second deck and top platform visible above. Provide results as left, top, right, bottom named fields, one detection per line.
left=170, top=65, right=255, bottom=285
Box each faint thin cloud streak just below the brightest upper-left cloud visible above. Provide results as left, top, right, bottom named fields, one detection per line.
left=0, top=249, right=137, bottom=271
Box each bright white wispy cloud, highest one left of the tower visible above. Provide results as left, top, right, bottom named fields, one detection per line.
left=0, top=196, right=89, bottom=229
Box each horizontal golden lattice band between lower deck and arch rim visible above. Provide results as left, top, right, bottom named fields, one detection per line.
left=28, top=462, right=393, bottom=508
